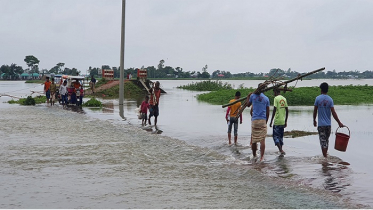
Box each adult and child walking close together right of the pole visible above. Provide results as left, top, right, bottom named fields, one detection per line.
left=140, top=81, right=161, bottom=126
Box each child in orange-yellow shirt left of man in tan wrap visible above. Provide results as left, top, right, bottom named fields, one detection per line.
left=225, top=91, right=242, bottom=145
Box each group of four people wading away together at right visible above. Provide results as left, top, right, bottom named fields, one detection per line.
left=225, top=82, right=344, bottom=161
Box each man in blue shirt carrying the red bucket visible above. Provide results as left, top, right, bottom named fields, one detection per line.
left=313, top=82, right=344, bottom=158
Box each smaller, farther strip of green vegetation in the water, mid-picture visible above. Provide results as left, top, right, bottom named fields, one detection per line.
left=177, top=80, right=232, bottom=91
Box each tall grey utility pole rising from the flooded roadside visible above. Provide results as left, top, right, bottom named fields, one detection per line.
left=119, top=0, right=126, bottom=119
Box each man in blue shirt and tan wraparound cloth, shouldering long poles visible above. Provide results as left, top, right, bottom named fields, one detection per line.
left=246, top=84, right=269, bottom=161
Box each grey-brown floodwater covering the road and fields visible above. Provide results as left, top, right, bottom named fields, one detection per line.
left=0, top=80, right=373, bottom=208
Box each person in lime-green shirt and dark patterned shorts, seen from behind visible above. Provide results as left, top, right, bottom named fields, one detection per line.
left=269, top=88, right=289, bottom=155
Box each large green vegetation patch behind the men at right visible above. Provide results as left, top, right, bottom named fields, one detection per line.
left=197, top=85, right=373, bottom=106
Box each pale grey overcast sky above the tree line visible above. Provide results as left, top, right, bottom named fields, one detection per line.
left=0, top=0, right=373, bottom=74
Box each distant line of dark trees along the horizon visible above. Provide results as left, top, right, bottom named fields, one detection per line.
left=0, top=55, right=373, bottom=80
